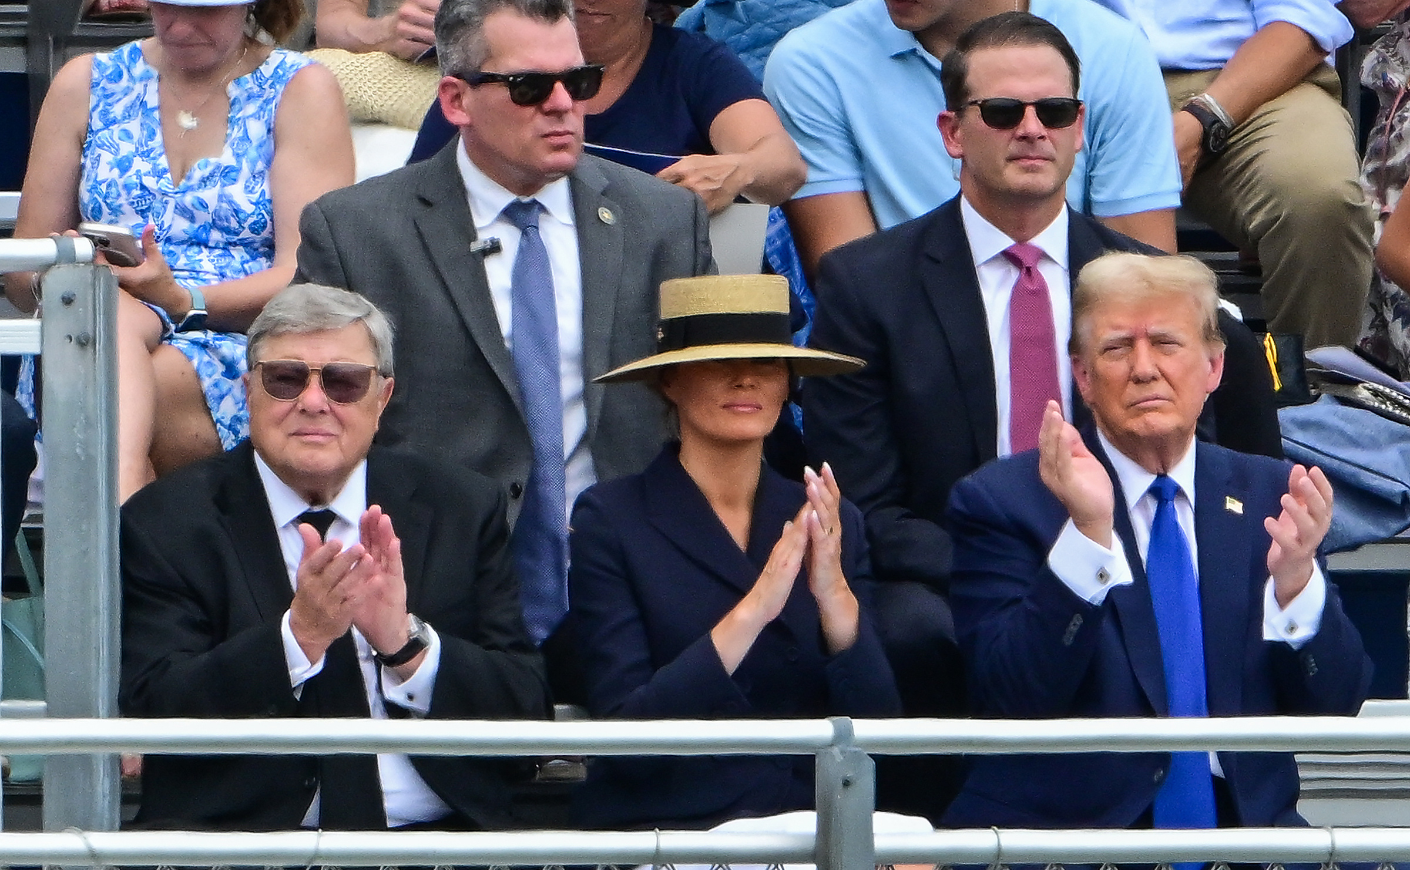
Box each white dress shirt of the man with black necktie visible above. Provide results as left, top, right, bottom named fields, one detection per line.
left=255, top=453, right=451, bottom=828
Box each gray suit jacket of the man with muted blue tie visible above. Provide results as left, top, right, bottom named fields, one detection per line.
left=296, top=138, right=715, bottom=522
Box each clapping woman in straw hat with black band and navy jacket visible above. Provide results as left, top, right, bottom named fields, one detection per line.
left=568, top=275, right=901, bottom=828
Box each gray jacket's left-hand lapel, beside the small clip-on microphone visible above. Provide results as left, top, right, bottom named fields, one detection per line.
left=413, top=145, right=523, bottom=416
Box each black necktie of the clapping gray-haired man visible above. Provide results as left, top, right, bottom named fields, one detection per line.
left=299, top=508, right=386, bottom=831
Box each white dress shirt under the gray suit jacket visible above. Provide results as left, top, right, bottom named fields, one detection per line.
left=455, top=145, right=596, bottom=515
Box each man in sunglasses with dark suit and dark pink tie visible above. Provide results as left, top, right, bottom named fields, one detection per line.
left=802, top=13, right=1282, bottom=821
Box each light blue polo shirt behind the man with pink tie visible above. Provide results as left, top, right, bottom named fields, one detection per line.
left=764, top=0, right=1180, bottom=228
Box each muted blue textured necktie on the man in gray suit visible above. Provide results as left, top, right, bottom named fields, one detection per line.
left=503, top=199, right=568, bottom=643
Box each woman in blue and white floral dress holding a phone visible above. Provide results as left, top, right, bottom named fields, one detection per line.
left=6, top=0, right=353, bottom=499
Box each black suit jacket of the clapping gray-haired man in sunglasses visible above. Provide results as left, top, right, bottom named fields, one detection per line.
left=120, top=441, right=548, bottom=829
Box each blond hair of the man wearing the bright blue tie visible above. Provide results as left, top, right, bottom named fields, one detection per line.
left=1067, top=252, right=1224, bottom=357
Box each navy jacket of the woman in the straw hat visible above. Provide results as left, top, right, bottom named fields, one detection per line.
left=568, top=447, right=901, bottom=828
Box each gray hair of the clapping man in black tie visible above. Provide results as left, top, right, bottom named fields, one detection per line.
left=245, top=283, right=392, bottom=378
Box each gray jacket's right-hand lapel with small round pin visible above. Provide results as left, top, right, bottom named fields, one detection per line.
left=568, top=158, right=626, bottom=441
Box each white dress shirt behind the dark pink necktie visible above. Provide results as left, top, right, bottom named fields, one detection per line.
left=960, top=196, right=1072, bottom=457
